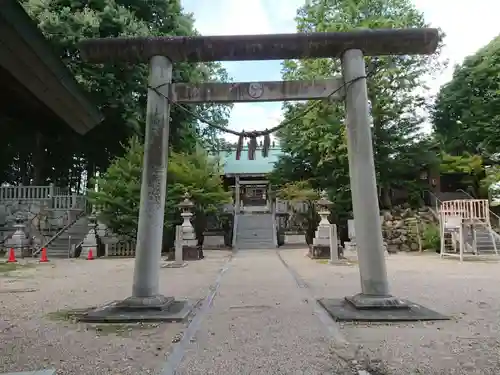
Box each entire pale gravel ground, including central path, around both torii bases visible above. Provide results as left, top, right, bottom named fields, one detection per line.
left=0, top=250, right=500, bottom=375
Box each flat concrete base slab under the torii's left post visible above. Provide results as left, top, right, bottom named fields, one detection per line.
left=79, top=299, right=199, bottom=323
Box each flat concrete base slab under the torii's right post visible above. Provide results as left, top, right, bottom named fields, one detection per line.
left=318, top=298, right=450, bottom=322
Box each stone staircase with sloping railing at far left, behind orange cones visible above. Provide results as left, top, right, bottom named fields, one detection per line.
left=47, top=216, right=88, bottom=259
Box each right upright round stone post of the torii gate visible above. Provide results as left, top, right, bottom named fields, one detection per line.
left=342, top=49, right=391, bottom=304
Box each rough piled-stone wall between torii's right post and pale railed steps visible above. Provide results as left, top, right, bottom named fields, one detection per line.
left=382, top=206, right=435, bottom=252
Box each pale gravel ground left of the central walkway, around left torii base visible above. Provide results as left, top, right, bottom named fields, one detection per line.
left=0, top=251, right=230, bottom=375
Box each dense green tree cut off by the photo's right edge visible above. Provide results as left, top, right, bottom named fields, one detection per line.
left=432, top=36, right=500, bottom=156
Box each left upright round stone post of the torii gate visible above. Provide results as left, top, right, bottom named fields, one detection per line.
left=128, top=56, right=174, bottom=309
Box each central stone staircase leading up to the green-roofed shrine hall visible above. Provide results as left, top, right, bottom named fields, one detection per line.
left=236, top=212, right=276, bottom=250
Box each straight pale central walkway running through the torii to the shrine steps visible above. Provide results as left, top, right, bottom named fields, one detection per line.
left=162, top=250, right=360, bottom=375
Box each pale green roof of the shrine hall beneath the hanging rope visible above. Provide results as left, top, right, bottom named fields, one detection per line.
left=219, top=147, right=283, bottom=175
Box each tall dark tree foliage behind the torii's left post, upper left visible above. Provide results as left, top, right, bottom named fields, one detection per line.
left=0, top=0, right=228, bottom=191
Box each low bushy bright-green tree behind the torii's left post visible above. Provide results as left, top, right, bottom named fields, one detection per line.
left=90, top=137, right=230, bottom=248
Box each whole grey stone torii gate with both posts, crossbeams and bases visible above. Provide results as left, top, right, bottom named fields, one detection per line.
left=80, top=29, right=450, bottom=321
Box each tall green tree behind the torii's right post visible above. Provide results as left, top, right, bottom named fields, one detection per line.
left=278, top=0, right=440, bottom=212
